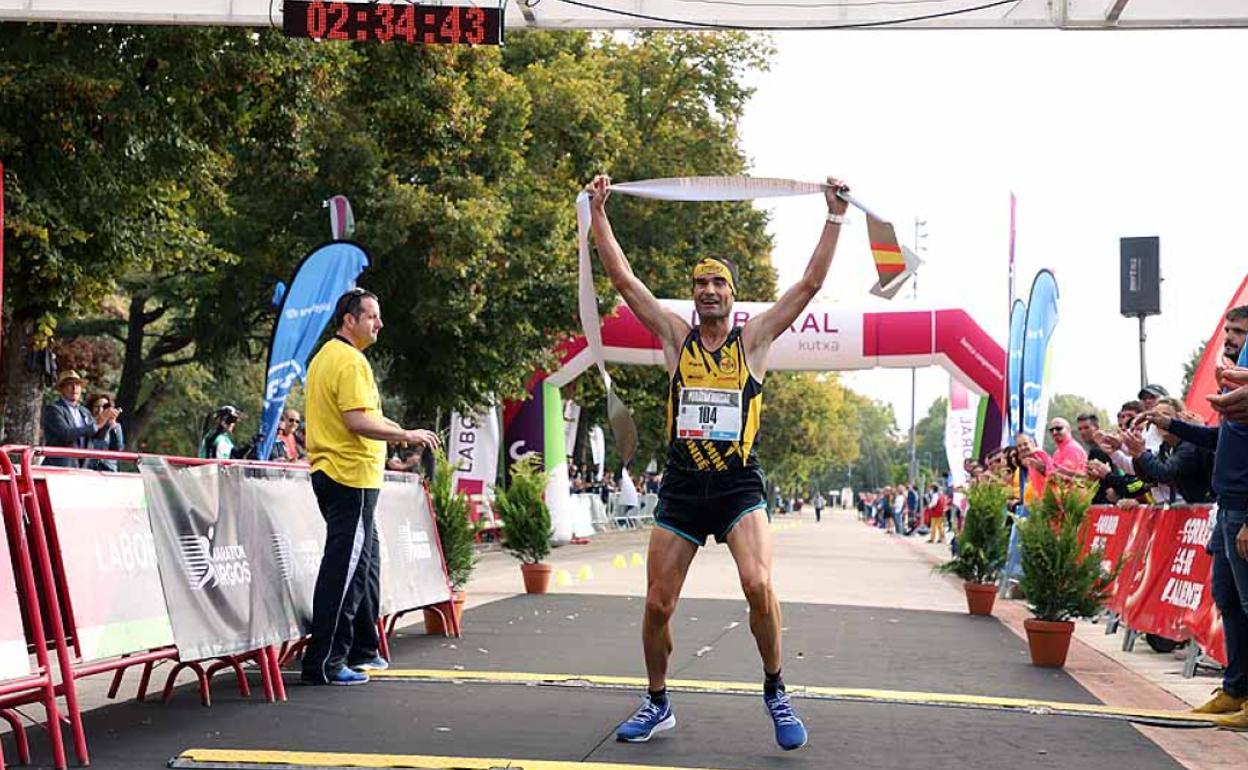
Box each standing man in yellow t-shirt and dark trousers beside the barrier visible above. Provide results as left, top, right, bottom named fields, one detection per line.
left=302, top=288, right=438, bottom=685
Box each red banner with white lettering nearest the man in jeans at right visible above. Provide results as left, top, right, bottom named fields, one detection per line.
left=1122, top=507, right=1213, bottom=640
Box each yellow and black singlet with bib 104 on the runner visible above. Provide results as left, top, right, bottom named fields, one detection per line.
left=668, top=326, right=763, bottom=472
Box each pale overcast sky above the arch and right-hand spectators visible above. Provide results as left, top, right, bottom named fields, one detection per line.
left=743, top=30, right=1248, bottom=431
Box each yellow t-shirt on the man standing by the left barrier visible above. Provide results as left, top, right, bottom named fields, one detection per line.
left=303, top=337, right=386, bottom=489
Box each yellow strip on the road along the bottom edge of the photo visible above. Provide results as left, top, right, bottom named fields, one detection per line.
left=170, top=749, right=723, bottom=770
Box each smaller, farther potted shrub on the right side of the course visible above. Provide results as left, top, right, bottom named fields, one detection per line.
left=936, top=477, right=1010, bottom=615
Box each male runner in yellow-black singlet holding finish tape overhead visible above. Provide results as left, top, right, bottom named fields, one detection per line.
left=585, top=170, right=849, bottom=750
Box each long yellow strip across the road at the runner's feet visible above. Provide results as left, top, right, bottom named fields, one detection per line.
left=368, top=669, right=1217, bottom=728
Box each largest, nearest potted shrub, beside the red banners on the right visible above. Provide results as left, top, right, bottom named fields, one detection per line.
left=1016, top=478, right=1118, bottom=668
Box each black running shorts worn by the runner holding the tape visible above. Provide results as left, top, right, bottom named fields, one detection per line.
left=654, top=467, right=766, bottom=545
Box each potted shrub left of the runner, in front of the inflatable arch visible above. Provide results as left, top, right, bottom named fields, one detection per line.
left=494, top=453, right=552, bottom=594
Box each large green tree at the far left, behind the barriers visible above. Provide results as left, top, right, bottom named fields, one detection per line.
left=0, top=25, right=351, bottom=441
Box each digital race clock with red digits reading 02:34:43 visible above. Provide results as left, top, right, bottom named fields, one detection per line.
left=282, top=0, right=503, bottom=45
